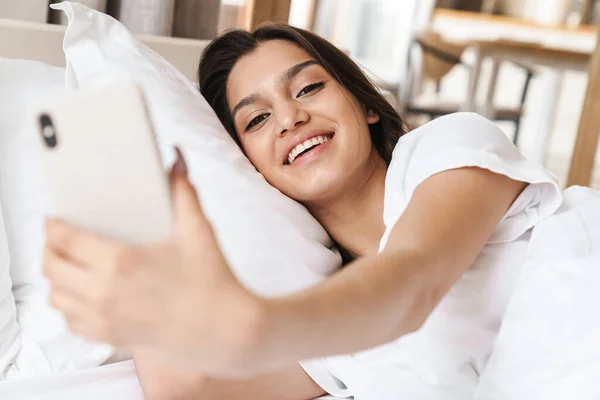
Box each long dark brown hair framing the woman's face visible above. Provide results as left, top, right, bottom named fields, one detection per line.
left=198, top=24, right=408, bottom=165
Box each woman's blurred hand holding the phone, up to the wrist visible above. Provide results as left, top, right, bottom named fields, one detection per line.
left=44, top=149, right=261, bottom=374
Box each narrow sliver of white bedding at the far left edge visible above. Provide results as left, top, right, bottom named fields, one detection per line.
left=0, top=203, right=21, bottom=380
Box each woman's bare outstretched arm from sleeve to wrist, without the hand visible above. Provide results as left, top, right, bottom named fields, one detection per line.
left=244, top=168, right=526, bottom=368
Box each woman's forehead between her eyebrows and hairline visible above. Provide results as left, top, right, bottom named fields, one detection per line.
left=227, top=40, right=312, bottom=107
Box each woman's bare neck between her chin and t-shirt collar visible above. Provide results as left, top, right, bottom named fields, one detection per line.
left=306, top=153, right=387, bottom=258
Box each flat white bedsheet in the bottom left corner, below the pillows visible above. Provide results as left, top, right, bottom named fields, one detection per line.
left=0, top=360, right=344, bottom=400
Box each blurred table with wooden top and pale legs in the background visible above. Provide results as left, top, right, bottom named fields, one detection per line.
left=430, top=10, right=597, bottom=170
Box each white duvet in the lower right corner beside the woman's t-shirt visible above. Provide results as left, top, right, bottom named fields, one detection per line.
left=475, top=187, right=600, bottom=400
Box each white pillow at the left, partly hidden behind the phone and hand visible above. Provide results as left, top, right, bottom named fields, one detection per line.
left=0, top=59, right=112, bottom=377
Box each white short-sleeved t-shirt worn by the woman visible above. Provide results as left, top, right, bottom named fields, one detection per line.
left=301, top=113, right=562, bottom=400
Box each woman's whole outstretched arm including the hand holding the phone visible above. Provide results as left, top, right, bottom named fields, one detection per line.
left=44, top=161, right=526, bottom=377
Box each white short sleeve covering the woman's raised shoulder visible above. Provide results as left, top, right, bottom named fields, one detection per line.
left=386, top=113, right=562, bottom=245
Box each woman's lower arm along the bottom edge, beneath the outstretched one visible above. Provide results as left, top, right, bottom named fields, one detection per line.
left=134, top=353, right=325, bottom=400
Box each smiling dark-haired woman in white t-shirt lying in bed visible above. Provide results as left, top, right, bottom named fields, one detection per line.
left=45, top=25, right=600, bottom=400
